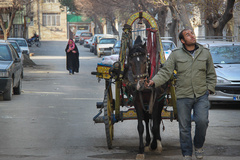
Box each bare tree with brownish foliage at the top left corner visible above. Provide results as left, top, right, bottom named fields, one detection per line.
left=0, top=0, right=27, bottom=40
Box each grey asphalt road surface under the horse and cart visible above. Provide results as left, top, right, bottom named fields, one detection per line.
left=0, top=41, right=240, bottom=160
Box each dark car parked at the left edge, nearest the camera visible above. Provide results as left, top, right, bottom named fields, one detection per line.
left=0, top=42, right=23, bottom=100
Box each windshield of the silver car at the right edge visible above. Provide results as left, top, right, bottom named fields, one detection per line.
left=210, top=45, right=240, bottom=64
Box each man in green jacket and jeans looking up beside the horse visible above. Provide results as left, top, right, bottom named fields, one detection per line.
left=148, top=29, right=216, bottom=160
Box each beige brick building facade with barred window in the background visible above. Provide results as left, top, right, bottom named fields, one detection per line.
left=28, top=0, right=68, bottom=40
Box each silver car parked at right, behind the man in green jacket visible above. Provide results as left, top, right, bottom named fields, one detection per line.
left=200, top=41, right=240, bottom=104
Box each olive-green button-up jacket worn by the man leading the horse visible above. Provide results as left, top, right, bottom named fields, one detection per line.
left=152, top=44, right=216, bottom=98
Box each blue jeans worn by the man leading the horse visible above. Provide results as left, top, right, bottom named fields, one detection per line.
left=177, top=91, right=210, bottom=156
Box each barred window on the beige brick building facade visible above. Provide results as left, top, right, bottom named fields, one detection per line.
left=43, top=13, right=60, bottom=26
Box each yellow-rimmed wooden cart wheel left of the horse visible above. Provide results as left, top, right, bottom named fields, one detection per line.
left=103, top=83, right=114, bottom=149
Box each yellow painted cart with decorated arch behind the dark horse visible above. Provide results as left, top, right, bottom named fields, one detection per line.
left=91, top=12, right=177, bottom=149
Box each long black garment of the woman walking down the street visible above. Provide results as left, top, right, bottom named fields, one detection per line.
left=65, top=45, right=79, bottom=72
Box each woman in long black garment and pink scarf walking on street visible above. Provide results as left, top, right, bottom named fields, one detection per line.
left=65, top=39, right=79, bottom=75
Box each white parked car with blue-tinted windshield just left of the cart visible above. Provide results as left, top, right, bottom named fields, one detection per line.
left=97, top=37, right=117, bottom=57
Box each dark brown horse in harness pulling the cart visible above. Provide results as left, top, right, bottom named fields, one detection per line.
left=124, top=40, right=167, bottom=159
